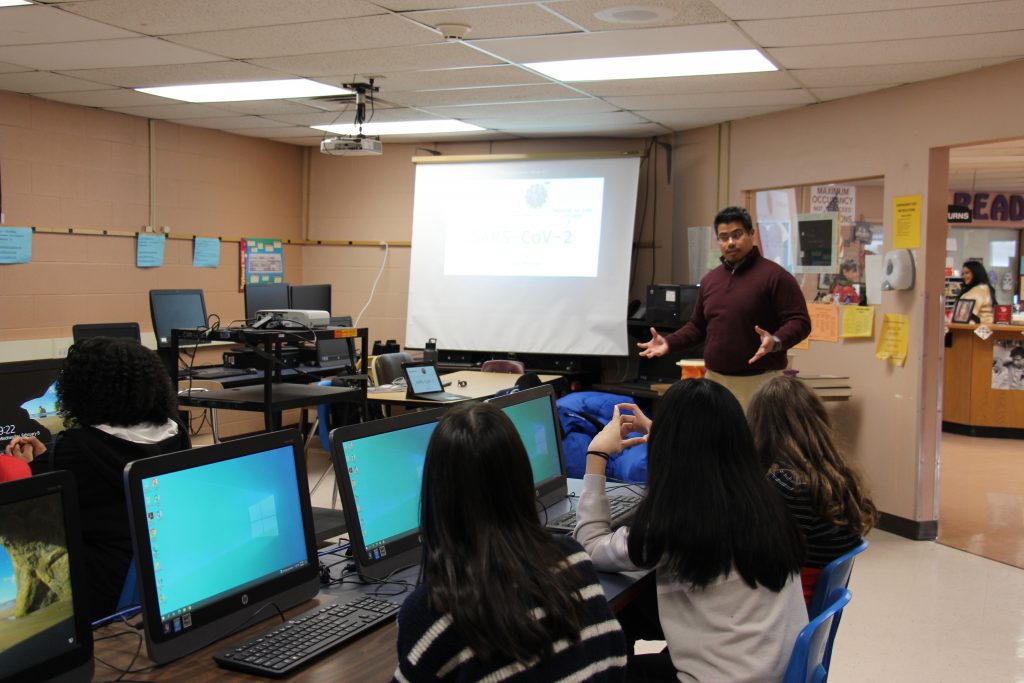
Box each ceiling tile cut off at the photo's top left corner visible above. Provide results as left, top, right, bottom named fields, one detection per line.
left=0, top=5, right=138, bottom=45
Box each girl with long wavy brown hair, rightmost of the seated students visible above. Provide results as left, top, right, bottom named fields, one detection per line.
left=746, top=376, right=878, bottom=602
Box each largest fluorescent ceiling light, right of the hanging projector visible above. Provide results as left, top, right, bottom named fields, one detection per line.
left=524, top=50, right=778, bottom=82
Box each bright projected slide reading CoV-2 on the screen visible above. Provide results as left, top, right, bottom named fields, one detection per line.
left=444, top=178, right=604, bottom=278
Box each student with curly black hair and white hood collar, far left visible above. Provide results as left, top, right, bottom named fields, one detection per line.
left=9, top=337, right=190, bottom=618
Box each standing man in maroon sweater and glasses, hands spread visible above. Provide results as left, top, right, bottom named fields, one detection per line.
left=638, top=207, right=811, bottom=410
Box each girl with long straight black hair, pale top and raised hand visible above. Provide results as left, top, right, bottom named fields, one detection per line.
left=575, top=379, right=807, bottom=682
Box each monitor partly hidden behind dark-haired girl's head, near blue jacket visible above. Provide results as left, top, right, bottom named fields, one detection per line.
left=488, top=384, right=568, bottom=507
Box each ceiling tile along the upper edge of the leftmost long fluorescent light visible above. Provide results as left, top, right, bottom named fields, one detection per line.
left=59, top=60, right=288, bottom=88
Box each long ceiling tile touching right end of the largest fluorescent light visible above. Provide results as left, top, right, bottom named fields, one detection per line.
left=770, top=31, right=1024, bottom=69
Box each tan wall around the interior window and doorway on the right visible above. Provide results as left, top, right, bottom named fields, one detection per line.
left=673, top=61, right=1024, bottom=520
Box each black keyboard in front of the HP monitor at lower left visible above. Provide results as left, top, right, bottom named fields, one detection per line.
left=213, top=597, right=399, bottom=678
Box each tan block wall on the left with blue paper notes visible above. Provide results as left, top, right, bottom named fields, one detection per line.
left=0, top=92, right=304, bottom=360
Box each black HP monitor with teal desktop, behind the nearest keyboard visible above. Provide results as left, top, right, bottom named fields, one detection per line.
left=124, top=430, right=319, bottom=664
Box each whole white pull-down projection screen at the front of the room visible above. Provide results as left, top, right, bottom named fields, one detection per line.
left=406, top=157, right=640, bottom=355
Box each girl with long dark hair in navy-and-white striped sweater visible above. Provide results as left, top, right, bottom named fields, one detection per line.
left=394, top=403, right=626, bottom=681
